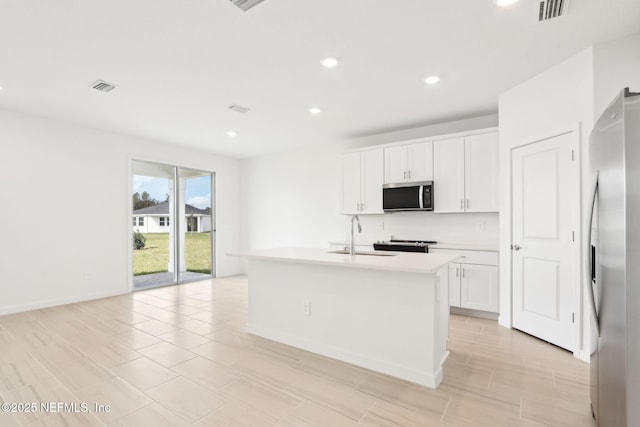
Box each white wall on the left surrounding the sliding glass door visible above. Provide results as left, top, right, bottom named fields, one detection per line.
left=0, top=111, right=241, bottom=314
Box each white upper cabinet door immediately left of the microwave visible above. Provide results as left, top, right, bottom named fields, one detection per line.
left=360, top=148, right=384, bottom=214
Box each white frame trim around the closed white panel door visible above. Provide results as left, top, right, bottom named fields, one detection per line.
left=498, top=122, right=584, bottom=357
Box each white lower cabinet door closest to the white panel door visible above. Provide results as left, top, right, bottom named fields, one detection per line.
left=460, top=264, right=498, bottom=313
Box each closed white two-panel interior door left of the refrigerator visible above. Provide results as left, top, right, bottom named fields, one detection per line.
left=512, top=133, right=580, bottom=351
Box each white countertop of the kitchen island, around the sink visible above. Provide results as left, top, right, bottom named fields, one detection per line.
left=227, top=248, right=459, bottom=274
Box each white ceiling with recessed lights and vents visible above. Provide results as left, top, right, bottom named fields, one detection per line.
left=0, top=0, right=640, bottom=157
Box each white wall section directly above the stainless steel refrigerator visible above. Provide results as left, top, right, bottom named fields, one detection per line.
left=593, top=33, right=640, bottom=120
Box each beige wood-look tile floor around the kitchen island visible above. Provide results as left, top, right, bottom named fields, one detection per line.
left=0, top=276, right=593, bottom=427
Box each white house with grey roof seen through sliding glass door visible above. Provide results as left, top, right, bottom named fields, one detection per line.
left=133, top=202, right=211, bottom=233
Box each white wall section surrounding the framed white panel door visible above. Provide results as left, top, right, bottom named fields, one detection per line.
left=499, top=48, right=593, bottom=357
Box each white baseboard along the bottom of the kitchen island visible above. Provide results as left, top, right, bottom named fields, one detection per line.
left=247, top=324, right=448, bottom=388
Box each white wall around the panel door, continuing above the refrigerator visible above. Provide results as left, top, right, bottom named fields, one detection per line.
left=499, top=33, right=640, bottom=360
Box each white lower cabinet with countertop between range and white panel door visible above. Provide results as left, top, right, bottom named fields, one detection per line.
left=429, top=248, right=498, bottom=313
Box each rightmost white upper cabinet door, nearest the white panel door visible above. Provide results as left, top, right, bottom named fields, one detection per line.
left=464, top=132, right=499, bottom=212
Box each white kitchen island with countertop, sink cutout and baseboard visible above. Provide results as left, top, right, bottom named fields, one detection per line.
left=230, top=248, right=457, bottom=388
